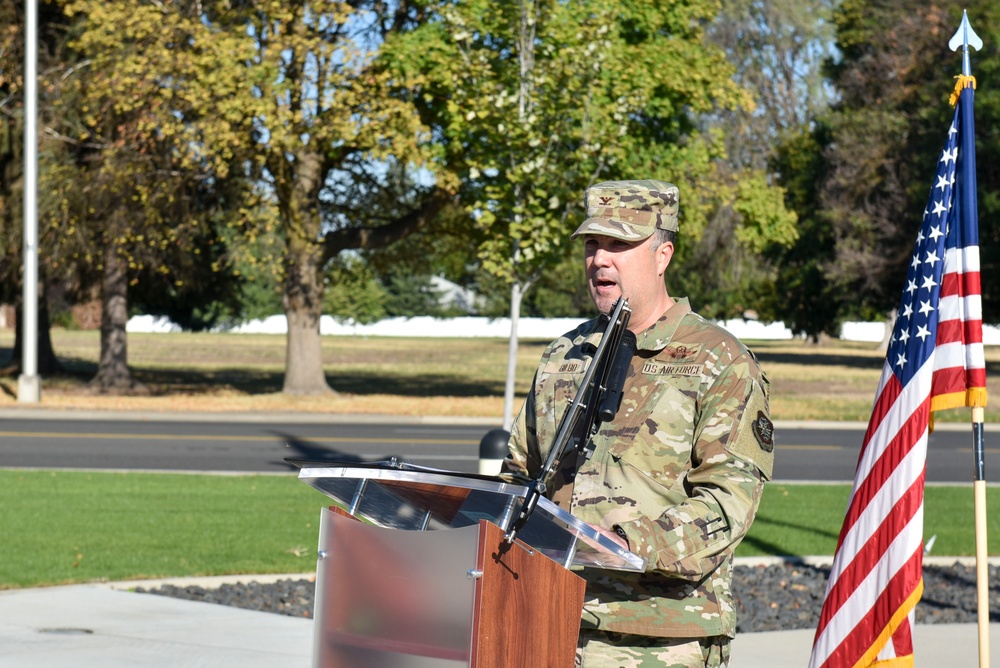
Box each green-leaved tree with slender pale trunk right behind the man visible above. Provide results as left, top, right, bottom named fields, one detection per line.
left=387, top=0, right=794, bottom=420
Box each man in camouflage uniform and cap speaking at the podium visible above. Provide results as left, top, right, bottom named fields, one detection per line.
left=504, top=180, right=774, bottom=668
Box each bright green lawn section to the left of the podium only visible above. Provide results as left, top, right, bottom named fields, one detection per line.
left=0, top=470, right=329, bottom=588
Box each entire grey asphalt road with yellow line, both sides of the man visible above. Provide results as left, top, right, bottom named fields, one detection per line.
left=0, top=412, right=1000, bottom=483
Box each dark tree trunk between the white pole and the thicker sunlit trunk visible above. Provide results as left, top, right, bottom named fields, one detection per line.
left=90, top=243, right=145, bottom=394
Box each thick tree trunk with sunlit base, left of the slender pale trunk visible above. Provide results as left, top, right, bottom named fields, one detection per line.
left=282, top=237, right=333, bottom=394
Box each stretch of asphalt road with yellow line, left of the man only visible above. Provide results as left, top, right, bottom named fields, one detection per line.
left=0, top=416, right=490, bottom=473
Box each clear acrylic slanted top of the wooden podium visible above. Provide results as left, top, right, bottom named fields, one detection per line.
left=287, top=459, right=646, bottom=573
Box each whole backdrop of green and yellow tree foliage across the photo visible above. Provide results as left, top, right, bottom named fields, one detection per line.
left=27, top=0, right=1000, bottom=354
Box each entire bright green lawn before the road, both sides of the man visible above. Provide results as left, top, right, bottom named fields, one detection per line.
left=0, top=470, right=1000, bottom=588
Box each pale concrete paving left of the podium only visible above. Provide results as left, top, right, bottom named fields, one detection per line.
left=0, top=585, right=312, bottom=668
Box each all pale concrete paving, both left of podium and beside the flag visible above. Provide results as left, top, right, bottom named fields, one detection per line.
left=0, top=576, right=1000, bottom=668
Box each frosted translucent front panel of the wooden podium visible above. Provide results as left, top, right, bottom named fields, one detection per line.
left=313, top=509, right=479, bottom=668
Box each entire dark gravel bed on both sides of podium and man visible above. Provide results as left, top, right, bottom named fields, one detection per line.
left=136, top=563, right=1000, bottom=633
